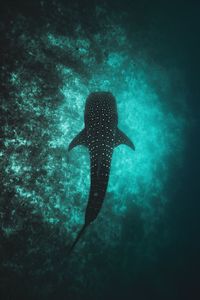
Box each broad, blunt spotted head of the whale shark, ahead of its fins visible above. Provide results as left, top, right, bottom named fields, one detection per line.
left=85, top=92, right=117, bottom=121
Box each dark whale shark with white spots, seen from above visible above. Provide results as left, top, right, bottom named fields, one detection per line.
left=68, top=92, right=135, bottom=253
